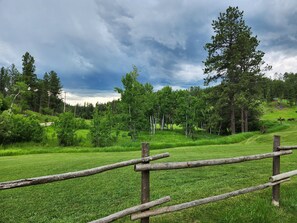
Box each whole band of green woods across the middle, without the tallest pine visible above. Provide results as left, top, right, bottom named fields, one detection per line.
left=0, top=53, right=297, bottom=146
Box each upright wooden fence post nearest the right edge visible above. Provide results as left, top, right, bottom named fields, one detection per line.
left=272, top=135, right=280, bottom=207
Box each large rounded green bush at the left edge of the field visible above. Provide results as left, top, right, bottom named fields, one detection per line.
left=0, top=111, right=44, bottom=144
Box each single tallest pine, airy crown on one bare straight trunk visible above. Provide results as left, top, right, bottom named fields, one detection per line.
left=204, top=7, right=264, bottom=134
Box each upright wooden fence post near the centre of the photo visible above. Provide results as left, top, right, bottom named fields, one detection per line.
left=140, top=143, right=150, bottom=223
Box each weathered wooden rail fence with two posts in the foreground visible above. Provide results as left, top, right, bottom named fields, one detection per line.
left=0, top=136, right=297, bottom=223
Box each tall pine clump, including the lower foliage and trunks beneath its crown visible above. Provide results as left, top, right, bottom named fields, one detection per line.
left=204, top=6, right=264, bottom=134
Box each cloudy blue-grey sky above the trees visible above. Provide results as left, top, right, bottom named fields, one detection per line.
left=0, top=0, right=297, bottom=105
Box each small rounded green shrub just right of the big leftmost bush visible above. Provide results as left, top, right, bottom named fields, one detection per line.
left=55, top=112, right=77, bottom=146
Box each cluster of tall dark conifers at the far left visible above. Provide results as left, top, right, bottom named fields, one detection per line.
left=0, top=52, right=63, bottom=115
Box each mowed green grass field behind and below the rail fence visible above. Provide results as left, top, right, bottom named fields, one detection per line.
left=0, top=104, right=297, bottom=223
